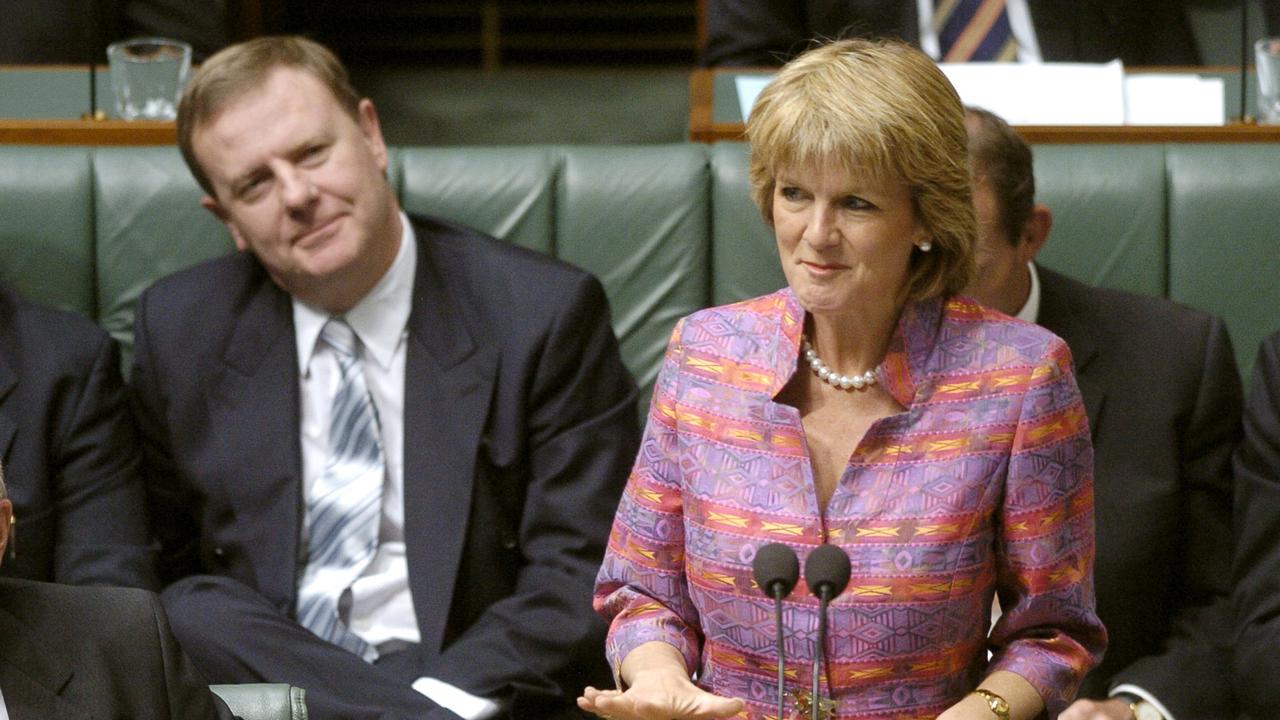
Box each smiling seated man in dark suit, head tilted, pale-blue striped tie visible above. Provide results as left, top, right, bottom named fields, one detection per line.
left=133, top=37, right=637, bottom=719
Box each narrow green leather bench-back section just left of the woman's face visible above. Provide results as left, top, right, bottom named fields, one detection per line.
left=712, top=142, right=786, bottom=305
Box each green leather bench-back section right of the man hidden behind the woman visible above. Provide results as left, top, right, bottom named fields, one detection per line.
left=1033, top=145, right=1169, bottom=296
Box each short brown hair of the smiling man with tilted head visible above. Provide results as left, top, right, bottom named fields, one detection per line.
left=178, top=36, right=360, bottom=195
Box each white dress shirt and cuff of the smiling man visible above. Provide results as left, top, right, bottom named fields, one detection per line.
left=294, top=213, right=500, bottom=720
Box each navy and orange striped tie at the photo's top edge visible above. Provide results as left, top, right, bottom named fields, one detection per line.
left=933, top=0, right=1018, bottom=63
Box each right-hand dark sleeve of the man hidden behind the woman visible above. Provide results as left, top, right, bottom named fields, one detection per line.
left=1111, top=316, right=1242, bottom=717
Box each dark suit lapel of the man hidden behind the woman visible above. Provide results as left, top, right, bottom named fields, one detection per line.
left=1036, top=265, right=1106, bottom=438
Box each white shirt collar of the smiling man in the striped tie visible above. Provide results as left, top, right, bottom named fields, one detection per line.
left=293, top=211, right=417, bottom=377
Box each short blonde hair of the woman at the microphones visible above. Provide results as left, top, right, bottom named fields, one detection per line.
left=746, top=40, right=977, bottom=300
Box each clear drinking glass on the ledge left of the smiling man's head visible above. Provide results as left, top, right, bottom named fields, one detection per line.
left=106, top=37, right=191, bottom=120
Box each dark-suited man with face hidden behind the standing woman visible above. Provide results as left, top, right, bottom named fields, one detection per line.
left=966, top=110, right=1240, bottom=720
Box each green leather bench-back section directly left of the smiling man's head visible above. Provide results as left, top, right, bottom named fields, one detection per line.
left=93, top=147, right=233, bottom=352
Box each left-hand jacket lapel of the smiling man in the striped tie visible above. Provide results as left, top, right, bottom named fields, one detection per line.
left=210, top=274, right=302, bottom=600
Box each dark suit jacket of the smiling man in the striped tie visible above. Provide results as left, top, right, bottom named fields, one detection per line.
left=133, top=218, right=639, bottom=717
